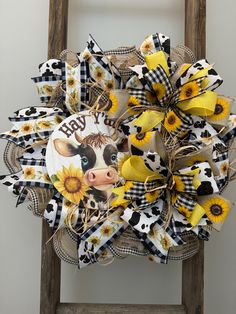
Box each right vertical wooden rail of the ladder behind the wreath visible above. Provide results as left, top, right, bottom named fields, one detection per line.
left=182, top=0, right=206, bottom=314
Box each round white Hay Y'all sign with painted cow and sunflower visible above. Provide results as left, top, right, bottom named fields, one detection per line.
left=46, top=111, right=122, bottom=208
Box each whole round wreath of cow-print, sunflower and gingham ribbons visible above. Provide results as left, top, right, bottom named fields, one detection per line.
left=0, top=33, right=236, bottom=268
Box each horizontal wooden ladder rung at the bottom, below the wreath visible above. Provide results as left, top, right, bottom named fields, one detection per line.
left=56, top=303, right=186, bottom=314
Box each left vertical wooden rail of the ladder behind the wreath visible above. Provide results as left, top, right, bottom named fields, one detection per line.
left=40, top=0, right=68, bottom=314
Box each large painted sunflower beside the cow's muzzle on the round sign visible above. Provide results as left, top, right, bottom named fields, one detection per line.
left=54, top=164, right=88, bottom=204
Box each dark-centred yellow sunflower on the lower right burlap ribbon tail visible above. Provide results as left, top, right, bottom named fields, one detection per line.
left=202, top=197, right=230, bottom=223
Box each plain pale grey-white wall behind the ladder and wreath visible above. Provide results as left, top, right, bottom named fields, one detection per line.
left=0, top=0, right=236, bottom=314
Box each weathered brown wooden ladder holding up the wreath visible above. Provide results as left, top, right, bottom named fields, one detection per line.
left=40, top=0, right=206, bottom=314
